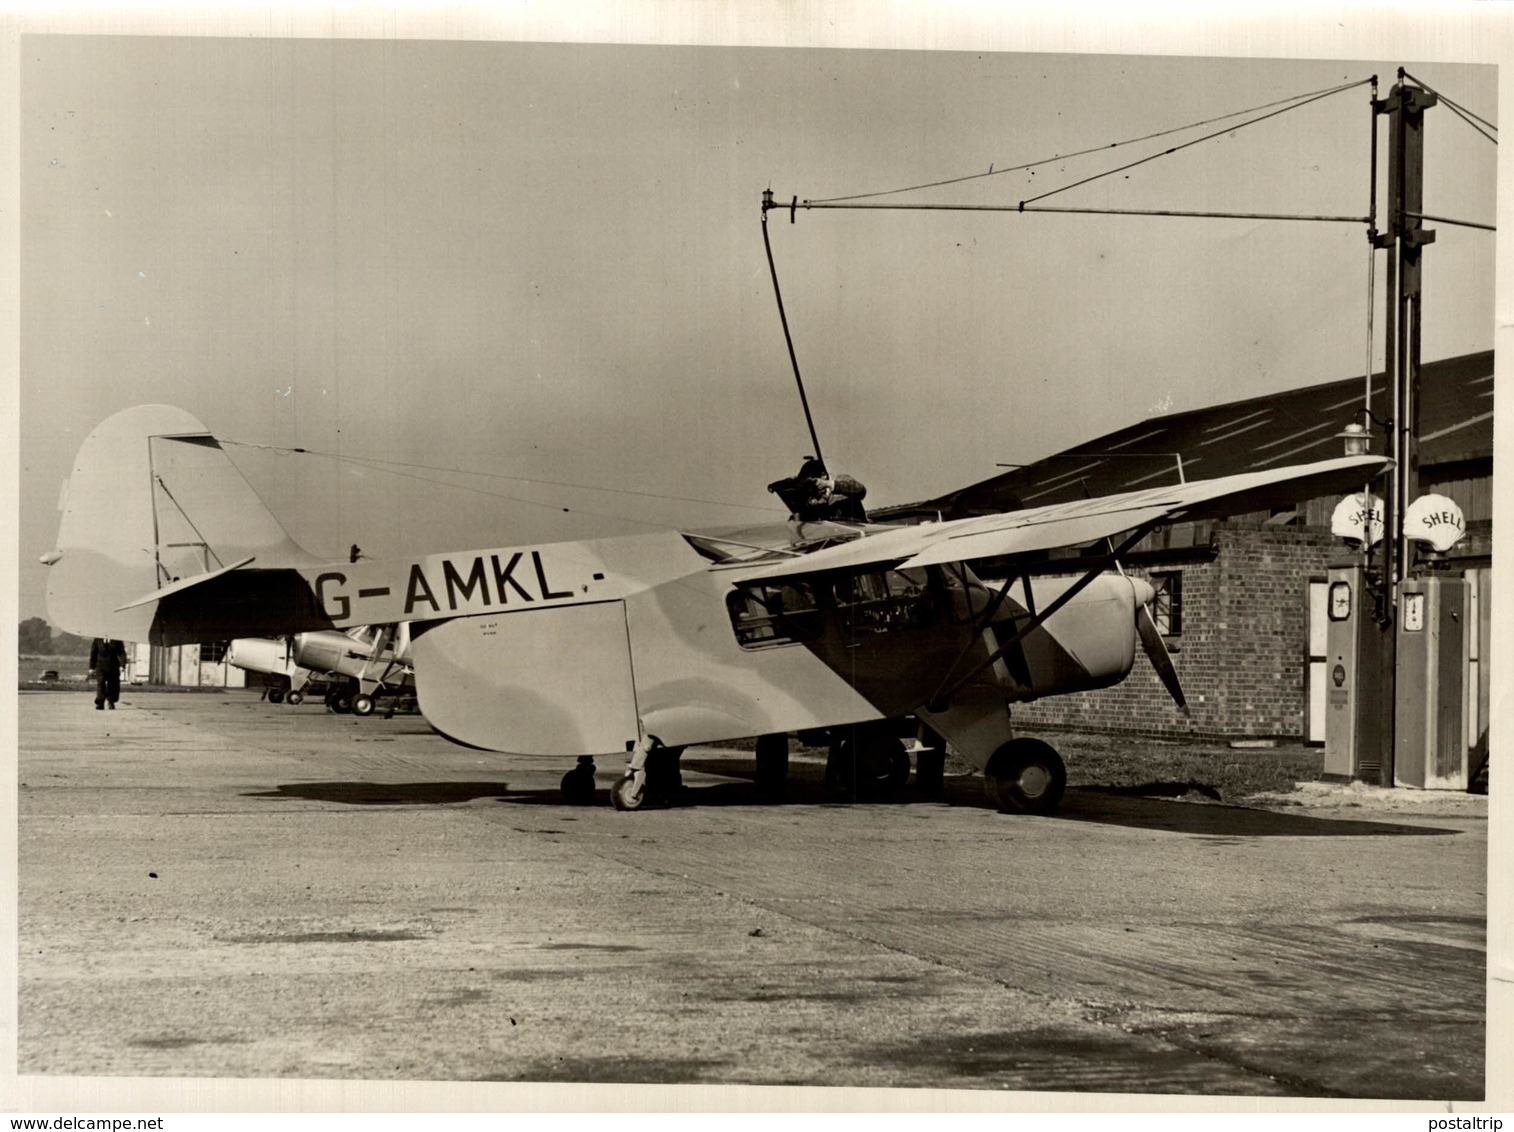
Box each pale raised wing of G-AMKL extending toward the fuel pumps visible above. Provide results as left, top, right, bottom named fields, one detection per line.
left=716, top=456, right=1393, bottom=583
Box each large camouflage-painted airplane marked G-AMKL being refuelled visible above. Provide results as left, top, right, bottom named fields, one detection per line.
left=44, top=406, right=1391, bottom=813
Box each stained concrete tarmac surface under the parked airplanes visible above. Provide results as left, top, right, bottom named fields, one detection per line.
left=18, top=689, right=1487, bottom=1100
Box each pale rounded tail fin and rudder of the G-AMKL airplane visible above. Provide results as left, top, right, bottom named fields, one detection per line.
left=44, top=406, right=318, bottom=642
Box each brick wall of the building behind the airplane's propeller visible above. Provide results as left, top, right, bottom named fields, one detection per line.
left=1013, top=519, right=1340, bottom=740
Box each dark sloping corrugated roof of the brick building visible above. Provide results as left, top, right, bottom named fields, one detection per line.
left=872, top=350, right=1493, bottom=519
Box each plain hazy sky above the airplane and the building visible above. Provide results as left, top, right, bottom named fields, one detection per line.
left=20, top=36, right=1497, bottom=617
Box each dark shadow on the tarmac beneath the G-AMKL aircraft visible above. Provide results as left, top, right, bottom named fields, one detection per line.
left=244, top=758, right=1459, bottom=838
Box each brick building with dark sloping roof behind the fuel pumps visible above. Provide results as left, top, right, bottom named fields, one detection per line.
left=874, top=351, right=1493, bottom=743
